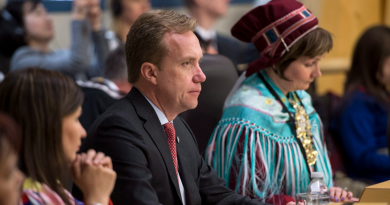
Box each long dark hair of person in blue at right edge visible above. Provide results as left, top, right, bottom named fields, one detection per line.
left=344, top=26, right=390, bottom=103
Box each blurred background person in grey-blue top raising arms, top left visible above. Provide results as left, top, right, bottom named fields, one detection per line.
left=0, top=0, right=108, bottom=79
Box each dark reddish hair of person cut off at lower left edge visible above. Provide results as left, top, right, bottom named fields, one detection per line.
left=0, top=112, right=21, bottom=162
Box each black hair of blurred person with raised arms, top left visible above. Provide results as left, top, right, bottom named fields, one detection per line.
left=0, top=0, right=40, bottom=57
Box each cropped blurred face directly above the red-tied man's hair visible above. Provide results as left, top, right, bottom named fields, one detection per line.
left=122, top=0, right=150, bottom=25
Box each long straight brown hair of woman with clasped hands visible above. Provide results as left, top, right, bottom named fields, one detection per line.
left=0, top=68, right=84, bottom=204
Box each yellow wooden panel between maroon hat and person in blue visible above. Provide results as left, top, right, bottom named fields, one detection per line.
left=301, top=0, right=382, bottom=95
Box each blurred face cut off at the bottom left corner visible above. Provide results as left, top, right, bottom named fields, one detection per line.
left=0, top=142, right=24, bottom=205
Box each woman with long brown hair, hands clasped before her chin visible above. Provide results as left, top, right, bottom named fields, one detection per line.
left=0, top=68, right=116, bottom=205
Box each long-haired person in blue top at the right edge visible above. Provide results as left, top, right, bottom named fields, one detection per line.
left=332, top=26, right=390, bottom=183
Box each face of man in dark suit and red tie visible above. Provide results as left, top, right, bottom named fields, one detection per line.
left=156, top=31, right=206, bottom=113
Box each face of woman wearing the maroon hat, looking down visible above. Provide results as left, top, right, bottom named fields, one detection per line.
left=283, top=55, right=324, bottom=91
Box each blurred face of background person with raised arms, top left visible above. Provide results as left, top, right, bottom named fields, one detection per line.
left=23, top=2, right=54, bottom=42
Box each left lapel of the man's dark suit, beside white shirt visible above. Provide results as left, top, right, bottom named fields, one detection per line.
left=127, top=87, right=181, bottom=203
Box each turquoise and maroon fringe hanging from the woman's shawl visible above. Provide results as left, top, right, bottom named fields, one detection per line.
left=205, top=118, right=333, bottom=201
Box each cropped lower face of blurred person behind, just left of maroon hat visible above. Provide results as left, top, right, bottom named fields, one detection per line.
left=197, top=0, right=230, bottom=18
